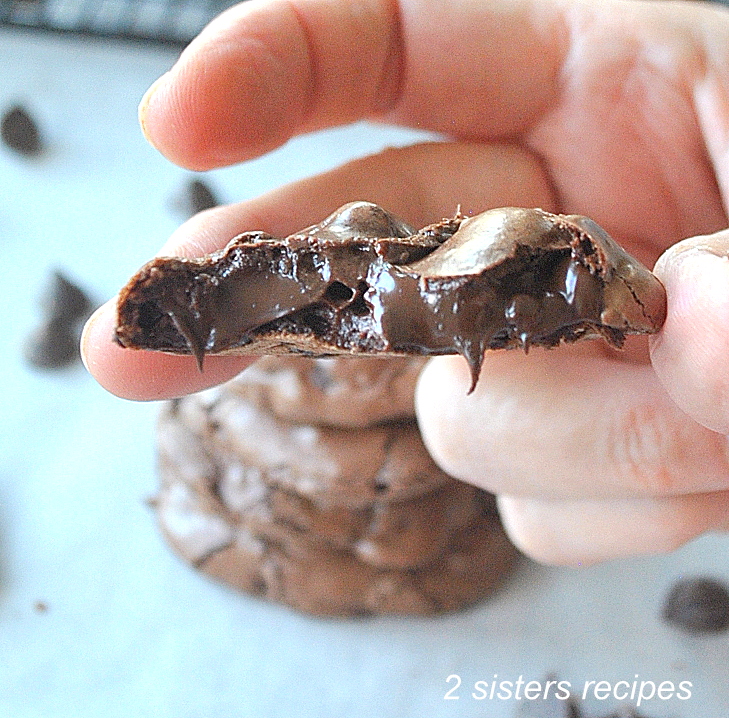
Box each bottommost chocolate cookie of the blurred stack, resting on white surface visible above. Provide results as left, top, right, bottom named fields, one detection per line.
left=201, top=522, right=514, bottom=616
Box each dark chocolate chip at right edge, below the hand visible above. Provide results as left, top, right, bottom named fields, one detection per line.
left=662, top=577, right=729, bottom=634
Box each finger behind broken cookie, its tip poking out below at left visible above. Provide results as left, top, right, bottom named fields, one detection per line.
left=82, top=143, right=552, bottom=399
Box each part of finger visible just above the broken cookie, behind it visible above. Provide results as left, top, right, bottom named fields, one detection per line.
left=155, top=142, right=555, bottom=257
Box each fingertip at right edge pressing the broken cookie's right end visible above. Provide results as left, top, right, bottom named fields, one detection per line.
left=651, top=230, right=729, bottom=434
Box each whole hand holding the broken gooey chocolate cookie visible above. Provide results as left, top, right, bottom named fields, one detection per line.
left=83, top=0, right=729, bottom=563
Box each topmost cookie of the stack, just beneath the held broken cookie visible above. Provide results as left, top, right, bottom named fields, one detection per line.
left=229, top=356, right=425, bottom=428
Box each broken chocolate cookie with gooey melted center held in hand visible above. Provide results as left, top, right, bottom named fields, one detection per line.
left=115, top=202, right=666, bottom=385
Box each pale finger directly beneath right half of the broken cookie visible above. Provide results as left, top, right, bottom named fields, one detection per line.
left=416, top=346, right=729, bottom=498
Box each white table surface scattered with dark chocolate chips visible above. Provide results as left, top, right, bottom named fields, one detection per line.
left=0, top=23, right=729, bottom=718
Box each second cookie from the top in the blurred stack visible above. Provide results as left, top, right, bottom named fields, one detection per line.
left=160, top=386, right=450, bottom=508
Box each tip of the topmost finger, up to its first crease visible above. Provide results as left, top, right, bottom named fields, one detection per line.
left=138, top=3, right=308, bottom=171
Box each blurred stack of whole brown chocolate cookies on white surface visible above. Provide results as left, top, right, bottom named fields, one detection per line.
left=155, top=356, right=518, bottom=615
